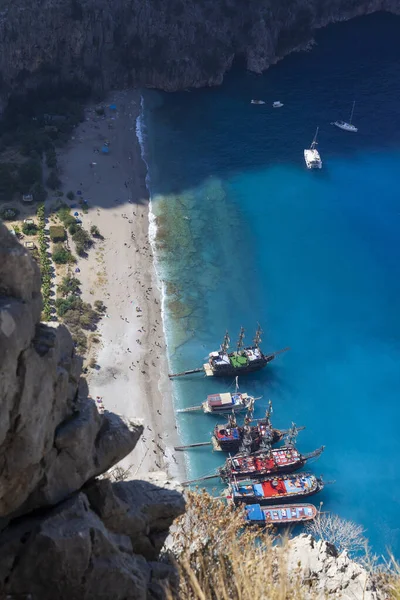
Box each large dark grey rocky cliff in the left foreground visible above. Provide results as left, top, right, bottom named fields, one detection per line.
left=0, top=224, right=184, bottom=600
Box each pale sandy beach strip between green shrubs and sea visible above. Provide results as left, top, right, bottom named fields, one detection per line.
left=59, top=90, right=184, bottom=479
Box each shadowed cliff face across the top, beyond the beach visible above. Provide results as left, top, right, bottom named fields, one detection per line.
left=0, top=0, right=400, bottom=108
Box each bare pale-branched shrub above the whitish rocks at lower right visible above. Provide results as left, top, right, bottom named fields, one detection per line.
left=305, top=513, right=367, bottom=555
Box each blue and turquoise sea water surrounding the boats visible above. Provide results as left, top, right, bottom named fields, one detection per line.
left=145, top=14, right=400, bottom=556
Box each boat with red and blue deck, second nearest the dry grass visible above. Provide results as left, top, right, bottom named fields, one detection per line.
left=227, top=473, right=324, bottom=504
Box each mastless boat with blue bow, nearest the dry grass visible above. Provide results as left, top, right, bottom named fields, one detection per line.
left=244, top=504, right=318, bottom=526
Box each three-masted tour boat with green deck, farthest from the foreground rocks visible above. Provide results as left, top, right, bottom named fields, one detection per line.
left=169, top=327, right=289, bottom=378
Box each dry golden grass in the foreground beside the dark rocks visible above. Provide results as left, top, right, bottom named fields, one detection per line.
left=167, top=492, right=317, bottom=600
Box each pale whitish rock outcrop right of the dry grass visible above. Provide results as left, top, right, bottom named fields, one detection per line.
left=287, top=534, right=386, bottom=600
